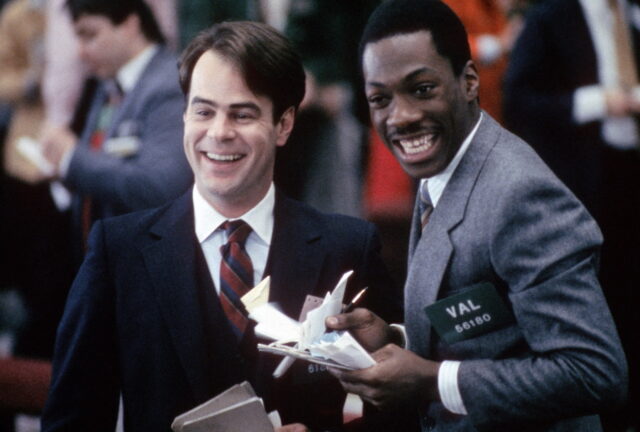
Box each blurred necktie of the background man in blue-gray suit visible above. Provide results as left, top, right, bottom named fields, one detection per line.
left=81, top=80, right=123, bottom=248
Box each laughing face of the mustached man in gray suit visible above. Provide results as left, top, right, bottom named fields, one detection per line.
left=362, top=31, right=479, bottom=178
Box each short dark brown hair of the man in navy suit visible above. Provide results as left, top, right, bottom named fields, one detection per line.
left=179, top=21, right=305, bottom=122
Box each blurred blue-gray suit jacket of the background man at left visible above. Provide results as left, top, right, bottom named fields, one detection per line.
left=64, top=47, right=193, bottom=218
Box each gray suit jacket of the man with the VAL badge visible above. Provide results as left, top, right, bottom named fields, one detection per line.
left=405, top=113, right=627, bottom=431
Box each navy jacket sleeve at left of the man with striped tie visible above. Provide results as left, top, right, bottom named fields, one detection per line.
left=42, top=222, right=120, bottom=432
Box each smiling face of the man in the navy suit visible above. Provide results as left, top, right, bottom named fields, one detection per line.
left=184, top=50, right=294, bottom=217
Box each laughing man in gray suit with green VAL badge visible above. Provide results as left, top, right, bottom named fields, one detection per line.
left=327, top=0, right=627, bottom=431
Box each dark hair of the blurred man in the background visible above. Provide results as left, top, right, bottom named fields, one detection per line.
left=66, top=0, right=165, bottom=43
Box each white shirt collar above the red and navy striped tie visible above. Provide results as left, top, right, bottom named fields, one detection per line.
left=193, top=183, right=276, bottom=245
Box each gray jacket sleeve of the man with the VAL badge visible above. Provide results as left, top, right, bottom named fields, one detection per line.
left=458, top=172, right=627, bottom=430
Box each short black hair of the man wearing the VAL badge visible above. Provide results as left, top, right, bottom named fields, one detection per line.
left=359, top=0, right=471, bottom=76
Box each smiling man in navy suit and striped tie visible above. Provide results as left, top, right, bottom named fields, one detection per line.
left=43, top=22, right=401, bottom=432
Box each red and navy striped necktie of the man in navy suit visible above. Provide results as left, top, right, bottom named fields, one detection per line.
left=220, top=220, right=253, bottom=340
